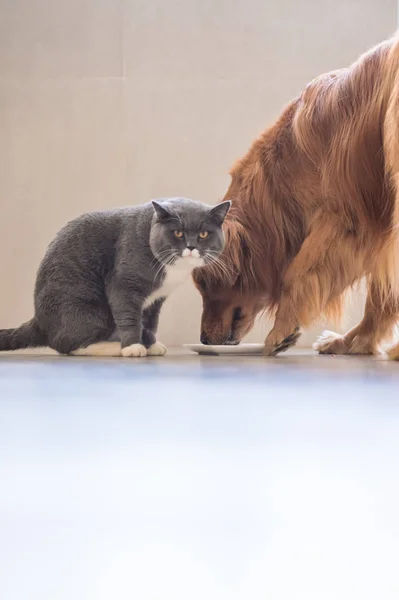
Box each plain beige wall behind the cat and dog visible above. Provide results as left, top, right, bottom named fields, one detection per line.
left=0, top=0, right=396, bottom=344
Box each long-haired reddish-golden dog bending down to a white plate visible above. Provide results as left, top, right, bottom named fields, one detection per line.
left=194, top=37, right=399, bottom=358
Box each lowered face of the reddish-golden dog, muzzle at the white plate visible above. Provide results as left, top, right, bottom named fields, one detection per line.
left=194, top=269, right=264, bottom=344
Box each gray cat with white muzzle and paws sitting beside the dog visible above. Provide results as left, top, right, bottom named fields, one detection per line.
left=0, top=198, right=230, bottom=356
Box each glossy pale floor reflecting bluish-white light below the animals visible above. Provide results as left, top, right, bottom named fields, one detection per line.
left=0, top=353, right=399, bottom=600
